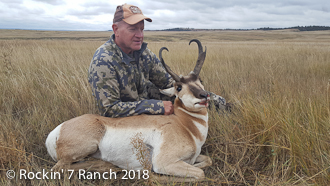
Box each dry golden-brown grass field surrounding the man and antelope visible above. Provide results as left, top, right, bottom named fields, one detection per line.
left=0, top=30, right=330, bottom=185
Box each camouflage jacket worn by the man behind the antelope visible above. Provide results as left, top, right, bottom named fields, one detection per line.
left=88, top=35, right=173, bottom=117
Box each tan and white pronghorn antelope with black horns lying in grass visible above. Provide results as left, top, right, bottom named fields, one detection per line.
left=46, top=39, right=212, bottom=179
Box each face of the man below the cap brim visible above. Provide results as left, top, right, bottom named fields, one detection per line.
left=112, top=20, right=144, bottom=54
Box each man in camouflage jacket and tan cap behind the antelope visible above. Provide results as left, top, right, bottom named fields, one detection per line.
left=88, top=4, right=226, bottom=117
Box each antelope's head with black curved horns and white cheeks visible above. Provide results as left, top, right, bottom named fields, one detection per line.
left=159, top=39, right=210, bottom=112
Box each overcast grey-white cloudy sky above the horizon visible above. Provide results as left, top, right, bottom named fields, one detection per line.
left=0, top=0, right=330, bottom=31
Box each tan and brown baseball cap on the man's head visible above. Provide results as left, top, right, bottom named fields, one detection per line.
left=113, top=3, right=152, bottom=25
